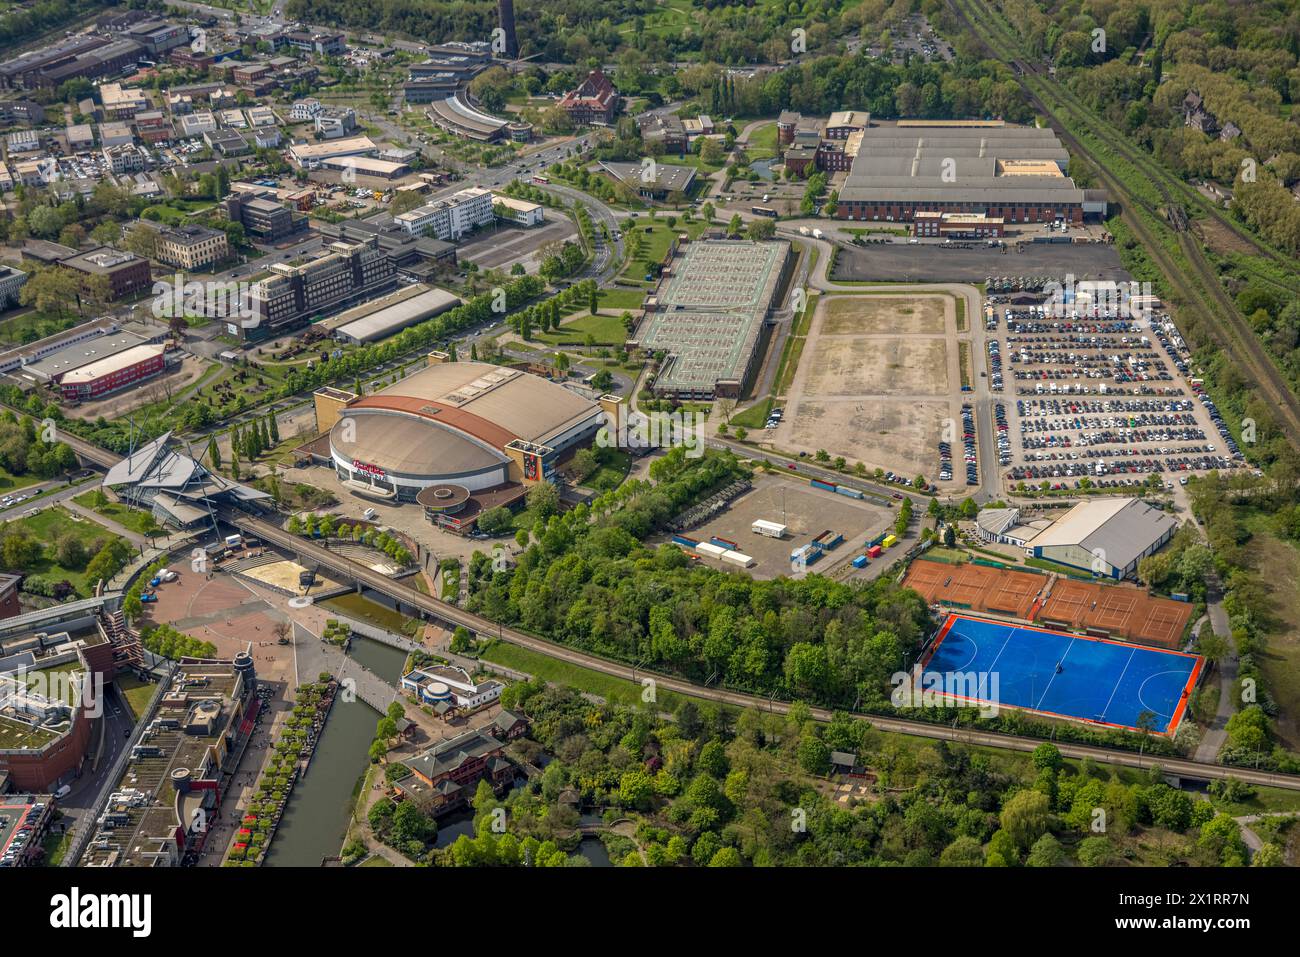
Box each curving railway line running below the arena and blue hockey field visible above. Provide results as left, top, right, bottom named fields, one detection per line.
left=50, top=429, right=1300, bottom=791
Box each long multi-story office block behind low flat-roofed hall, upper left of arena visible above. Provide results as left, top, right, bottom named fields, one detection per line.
left=244, top=238, right=397, bottom=339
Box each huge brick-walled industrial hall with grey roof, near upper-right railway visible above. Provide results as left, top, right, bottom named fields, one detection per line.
left=835, top=122, right=1105, bottom=226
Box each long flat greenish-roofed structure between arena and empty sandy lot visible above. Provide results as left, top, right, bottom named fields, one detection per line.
left=629, top=241, right=793, bottom=399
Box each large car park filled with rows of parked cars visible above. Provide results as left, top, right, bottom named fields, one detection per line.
left=988, top=287, right=1245, bottom=489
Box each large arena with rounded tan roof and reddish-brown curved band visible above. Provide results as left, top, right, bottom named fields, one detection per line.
left=316, top=352, right=605, bottom=502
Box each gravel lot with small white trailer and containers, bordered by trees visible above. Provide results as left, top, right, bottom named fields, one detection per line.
left=670, top=476, right=894, bottom=579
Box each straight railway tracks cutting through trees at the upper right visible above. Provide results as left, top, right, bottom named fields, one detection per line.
left=950, top=0, right=1300, bottom=445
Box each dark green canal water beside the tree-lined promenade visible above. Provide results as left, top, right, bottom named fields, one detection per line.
left=267, top=638, right=406, bottom=867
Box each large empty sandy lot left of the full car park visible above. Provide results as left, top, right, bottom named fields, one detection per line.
left=763, top=294, right=971, bottom=476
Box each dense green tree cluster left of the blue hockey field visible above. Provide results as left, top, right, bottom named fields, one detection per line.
left=471, top=449, right=928, bottom=705
